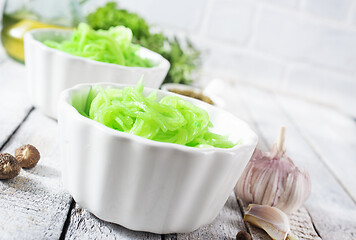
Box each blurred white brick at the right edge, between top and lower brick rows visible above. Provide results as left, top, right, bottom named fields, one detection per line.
left=255, top=8, right=356, bottom=73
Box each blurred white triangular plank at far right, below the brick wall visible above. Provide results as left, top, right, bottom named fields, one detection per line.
left=277, top=96, right=356, bottom=202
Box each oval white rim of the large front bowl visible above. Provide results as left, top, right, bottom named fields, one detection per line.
left=58, top=82, right=258, bottom=153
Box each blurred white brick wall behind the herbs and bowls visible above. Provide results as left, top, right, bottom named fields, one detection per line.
left=0, top=0, right=356, bottom=117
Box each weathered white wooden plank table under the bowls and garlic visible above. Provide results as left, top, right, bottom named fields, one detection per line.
left=0, top=53, right=356, bottom=240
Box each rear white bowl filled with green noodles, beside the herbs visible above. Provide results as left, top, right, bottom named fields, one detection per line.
left=24, top=23, right=170, bottom=118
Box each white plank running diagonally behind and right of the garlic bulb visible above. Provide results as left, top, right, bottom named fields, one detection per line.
left=236, top=85, right=356, bottom=239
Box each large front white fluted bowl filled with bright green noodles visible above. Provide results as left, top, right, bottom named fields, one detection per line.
left=58, top=83, right=257, bottom=234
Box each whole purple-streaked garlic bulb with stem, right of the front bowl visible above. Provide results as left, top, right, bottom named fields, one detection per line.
left=235, top=127, right=311, bottom=213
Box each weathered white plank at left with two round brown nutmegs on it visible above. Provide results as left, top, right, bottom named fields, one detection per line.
left=0, top=110, right=72, bottom=239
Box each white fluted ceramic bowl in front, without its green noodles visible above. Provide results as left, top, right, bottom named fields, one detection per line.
left=58, top=84, right=257, bottom=234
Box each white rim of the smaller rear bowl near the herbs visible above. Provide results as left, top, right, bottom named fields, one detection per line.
left=24, top=28, right=170, bottom=70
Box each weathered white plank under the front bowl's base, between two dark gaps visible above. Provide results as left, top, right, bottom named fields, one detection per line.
left=65, top=204, right=161, bottom=240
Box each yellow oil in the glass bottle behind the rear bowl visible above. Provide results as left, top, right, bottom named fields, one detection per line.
left=1, top=19, right=65, bottom=61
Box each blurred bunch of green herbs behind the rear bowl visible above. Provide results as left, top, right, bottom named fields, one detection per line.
left=87, top=2, right=200, bottom=84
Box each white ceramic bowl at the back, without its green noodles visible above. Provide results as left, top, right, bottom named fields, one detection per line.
left=24, top=29, right=170, bottom=118
